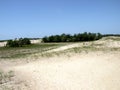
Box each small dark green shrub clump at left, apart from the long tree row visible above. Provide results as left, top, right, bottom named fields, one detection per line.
left=6, top=38, right=31, bottom=47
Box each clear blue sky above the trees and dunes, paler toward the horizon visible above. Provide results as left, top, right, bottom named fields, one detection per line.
left=0, top=0, right=120, bottom=39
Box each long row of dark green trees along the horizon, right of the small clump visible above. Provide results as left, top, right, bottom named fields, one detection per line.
left=42, top=32, right=102, bottom=42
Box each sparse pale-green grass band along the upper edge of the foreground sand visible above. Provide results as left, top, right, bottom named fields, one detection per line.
left=30, top=42, right=120, bottom=57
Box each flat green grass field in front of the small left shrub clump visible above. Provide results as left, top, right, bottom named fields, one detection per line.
left=0, top=43, right=66, bottom=59
